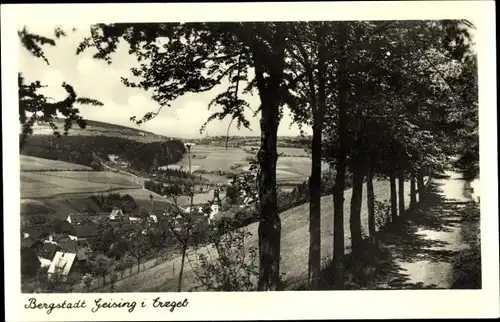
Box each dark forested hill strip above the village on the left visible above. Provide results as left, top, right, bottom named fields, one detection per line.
left=20, top=134, right=185, bottom=171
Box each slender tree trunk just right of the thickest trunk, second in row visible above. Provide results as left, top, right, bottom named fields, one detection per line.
left=308, top=27, right=326, bottom=290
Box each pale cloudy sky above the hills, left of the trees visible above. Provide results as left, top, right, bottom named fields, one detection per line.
left=19, top=25, right=309, bottom=138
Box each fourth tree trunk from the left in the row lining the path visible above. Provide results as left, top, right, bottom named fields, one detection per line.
left=349, top=160, right=363, bottom=254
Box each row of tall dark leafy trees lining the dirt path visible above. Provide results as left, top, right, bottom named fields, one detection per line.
left=18, top=20, right=478, bottom=291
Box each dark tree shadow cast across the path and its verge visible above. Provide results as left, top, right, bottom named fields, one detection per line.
left=312, top=182, right=467, bottom=290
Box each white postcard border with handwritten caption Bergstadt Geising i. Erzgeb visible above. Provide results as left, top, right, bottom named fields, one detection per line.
left=1, top=1, right=500, bottom=321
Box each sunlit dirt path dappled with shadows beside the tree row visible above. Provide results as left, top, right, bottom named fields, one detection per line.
left=374, top=171, right=470, bottom=289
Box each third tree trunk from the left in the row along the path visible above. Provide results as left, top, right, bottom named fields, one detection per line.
left=333, top=22, right=349, bottom=289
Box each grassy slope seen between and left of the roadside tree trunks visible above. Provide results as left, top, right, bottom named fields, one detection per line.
left=94, top=177, right=418, bottom=292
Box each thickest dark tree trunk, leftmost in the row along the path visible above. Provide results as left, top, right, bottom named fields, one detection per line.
left=253, top=25, right=285, bottom=291
